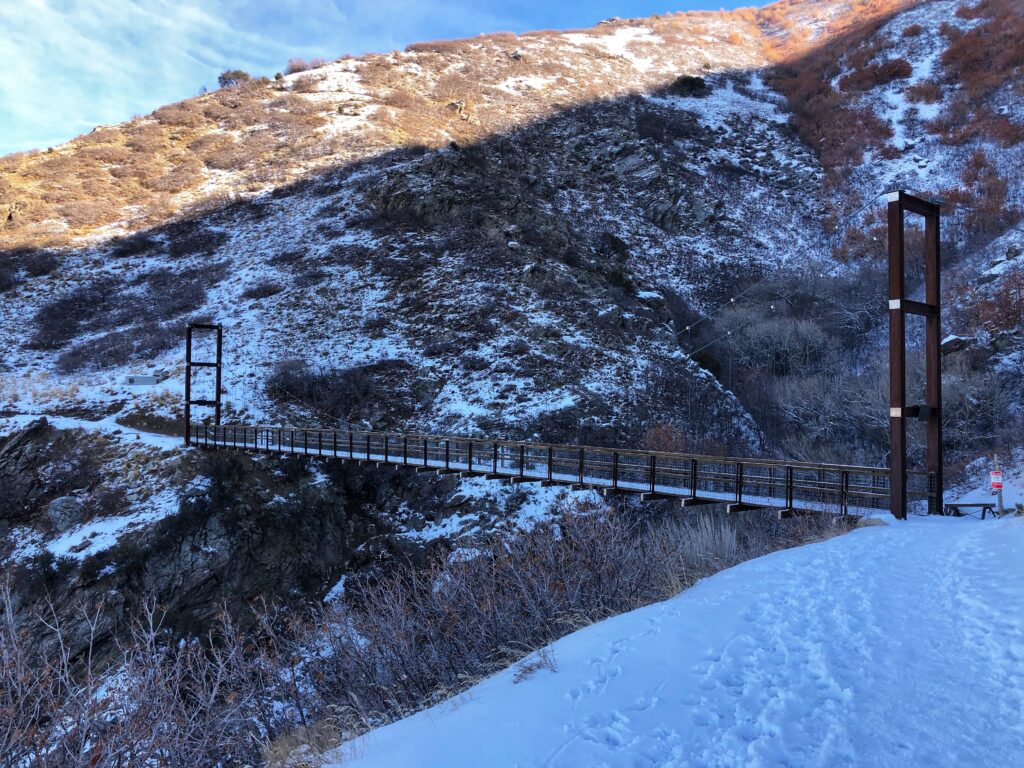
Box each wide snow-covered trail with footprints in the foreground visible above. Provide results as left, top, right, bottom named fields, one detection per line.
left=327, top=518, right=1024, bottom=768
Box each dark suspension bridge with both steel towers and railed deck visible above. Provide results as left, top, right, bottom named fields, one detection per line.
left=184, top=191, right=942, bottom=518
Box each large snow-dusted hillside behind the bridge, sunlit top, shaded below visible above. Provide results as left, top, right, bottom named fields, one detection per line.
left=0, top=0, right=1024, bottom=704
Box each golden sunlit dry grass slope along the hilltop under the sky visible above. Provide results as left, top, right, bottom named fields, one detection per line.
left=0, top=0, right=974, bottom=246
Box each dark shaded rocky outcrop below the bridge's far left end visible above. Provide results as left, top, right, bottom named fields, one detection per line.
left=0, top=430, right=477, bottom=654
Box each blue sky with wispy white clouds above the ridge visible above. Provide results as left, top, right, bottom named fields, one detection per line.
left=0, top=0, right=753, bottom=154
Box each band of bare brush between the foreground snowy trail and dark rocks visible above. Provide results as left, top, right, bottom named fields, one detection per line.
left=0, top=505, right=839, bottom=768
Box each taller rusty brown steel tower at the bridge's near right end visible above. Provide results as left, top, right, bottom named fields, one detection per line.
left=888, top=190, right=942, bottom=520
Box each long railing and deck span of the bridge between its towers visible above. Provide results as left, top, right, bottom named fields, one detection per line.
left=189, top=424, right=931, bottom=512
